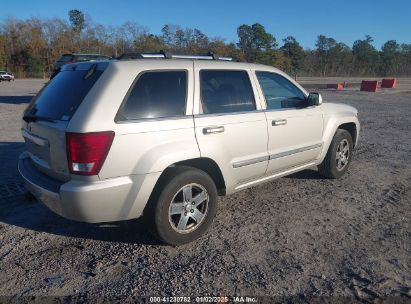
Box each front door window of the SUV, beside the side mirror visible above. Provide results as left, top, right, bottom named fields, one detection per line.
left=256, top=72, right=308, bottom=110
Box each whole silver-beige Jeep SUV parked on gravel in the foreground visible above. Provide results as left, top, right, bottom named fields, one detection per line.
left=18, top=53, right=360, bottom=245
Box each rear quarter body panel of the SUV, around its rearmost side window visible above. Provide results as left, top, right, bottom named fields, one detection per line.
left=67, top=59, right=200, bottom=179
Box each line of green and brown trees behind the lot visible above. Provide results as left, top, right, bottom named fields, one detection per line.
left=0, top=10, right=411, bottom=77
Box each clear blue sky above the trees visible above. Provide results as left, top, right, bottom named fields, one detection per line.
left=0, top=0, right=411, bottom=48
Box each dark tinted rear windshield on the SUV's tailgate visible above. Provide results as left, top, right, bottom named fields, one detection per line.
left=25, top=70, right=103, bottom=120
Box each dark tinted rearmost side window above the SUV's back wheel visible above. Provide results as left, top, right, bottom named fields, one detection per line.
left=120, top=71, right=187, bottom=119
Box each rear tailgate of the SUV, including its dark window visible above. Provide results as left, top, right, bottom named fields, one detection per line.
left=22, top=63, right=107, bottom=181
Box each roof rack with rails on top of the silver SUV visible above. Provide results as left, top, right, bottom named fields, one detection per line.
left=117, top=51, right=233, bottom=61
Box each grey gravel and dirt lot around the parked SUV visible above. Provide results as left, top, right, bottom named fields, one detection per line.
left=0, top=80, right=411, bottom=302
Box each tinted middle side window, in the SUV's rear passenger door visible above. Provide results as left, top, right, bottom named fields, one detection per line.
left=200, top=70, right=256, bottom=114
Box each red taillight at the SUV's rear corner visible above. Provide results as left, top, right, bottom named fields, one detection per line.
left=66, top=131, right=114, bottom=175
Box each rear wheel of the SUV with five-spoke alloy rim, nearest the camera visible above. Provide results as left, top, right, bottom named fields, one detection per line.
left=143, top=166, right=217, bottom=246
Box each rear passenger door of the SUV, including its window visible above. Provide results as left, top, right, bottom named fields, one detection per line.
left=194, top=61, right=268, bottom=188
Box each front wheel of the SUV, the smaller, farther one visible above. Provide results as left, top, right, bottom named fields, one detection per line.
left=318, top=129, right=353, bottom=179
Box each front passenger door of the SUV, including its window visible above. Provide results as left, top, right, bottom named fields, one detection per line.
left=255, top=71, right=323, bottom=173
